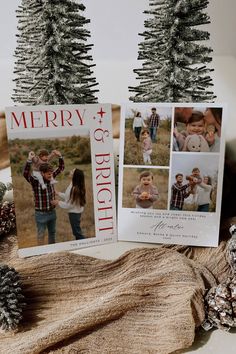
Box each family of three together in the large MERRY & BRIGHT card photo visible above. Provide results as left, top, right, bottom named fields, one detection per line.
left=23, top=149, right=86, bottom=245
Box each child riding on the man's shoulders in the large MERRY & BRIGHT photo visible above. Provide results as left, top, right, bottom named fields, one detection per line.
left=28, top=149, right=57, bottom=189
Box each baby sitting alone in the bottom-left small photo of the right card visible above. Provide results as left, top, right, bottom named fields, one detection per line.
left=133, top=171, right=158, bottom=209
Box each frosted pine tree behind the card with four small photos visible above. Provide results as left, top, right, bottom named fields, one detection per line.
left=129, top=0, right=215, bottom=102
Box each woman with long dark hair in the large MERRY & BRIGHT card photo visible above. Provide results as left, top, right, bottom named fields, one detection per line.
left=52, top=168, right=86, bottom=240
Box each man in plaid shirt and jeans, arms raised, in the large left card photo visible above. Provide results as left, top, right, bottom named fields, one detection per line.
left=23, top=150, right=64, bottom=245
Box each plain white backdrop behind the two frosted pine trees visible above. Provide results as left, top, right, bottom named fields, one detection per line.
left=0, top=0, right=236, bottom=153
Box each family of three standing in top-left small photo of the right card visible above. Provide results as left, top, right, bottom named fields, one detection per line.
left=133, top=107, right=160, bottom=165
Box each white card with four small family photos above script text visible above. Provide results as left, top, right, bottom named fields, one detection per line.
left=118, top=103, right=225, bottom=246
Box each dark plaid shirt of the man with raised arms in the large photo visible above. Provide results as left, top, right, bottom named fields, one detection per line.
left=23, top=157, right=64, bottom=212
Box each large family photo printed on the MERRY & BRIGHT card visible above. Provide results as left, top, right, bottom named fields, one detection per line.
left=9, top=132, right=95, bottom=248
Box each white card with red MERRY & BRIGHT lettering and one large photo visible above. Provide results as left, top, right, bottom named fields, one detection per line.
left=6, top=104, right=116, bottom=256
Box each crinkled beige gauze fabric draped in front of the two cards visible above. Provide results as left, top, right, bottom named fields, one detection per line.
left=0, top=232, right=232, bottom=354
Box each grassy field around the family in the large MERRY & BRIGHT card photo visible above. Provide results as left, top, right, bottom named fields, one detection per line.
left=9, top=136, right=95, bottom=248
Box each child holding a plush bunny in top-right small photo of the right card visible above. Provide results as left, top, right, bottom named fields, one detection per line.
left=174, top=111, right=210, bottom=152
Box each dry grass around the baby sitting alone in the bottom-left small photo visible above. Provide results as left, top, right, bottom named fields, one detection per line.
left=122, top=168, right=169, bottom=210
